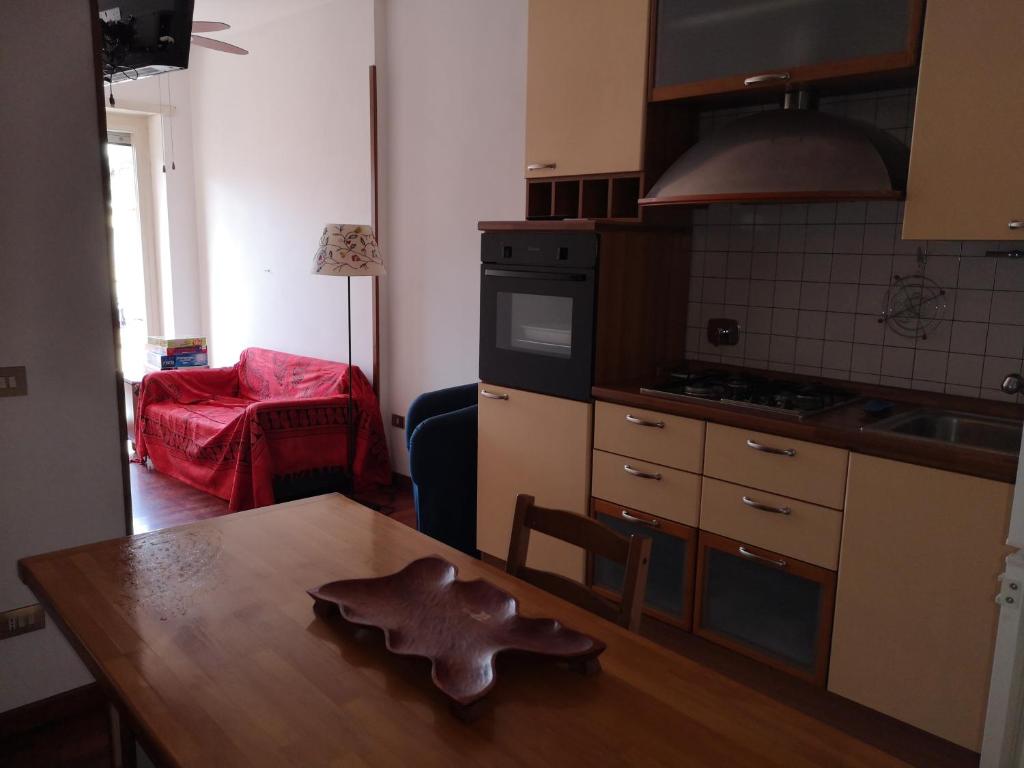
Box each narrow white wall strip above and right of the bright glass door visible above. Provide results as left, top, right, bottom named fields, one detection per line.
left=106, top=70, right=206, bottom=336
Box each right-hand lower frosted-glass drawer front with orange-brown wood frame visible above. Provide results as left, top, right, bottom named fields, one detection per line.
left=693, top=530, right=836, bottom=686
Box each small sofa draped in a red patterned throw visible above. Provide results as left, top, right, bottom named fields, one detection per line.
left=135, top=347, right=391, bottom=511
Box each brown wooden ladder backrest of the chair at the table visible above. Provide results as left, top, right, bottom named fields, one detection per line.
left=506, top=494, right=650, bottom=632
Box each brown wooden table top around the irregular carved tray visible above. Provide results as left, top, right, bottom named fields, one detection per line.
left=18, top=495, right=905, bottom=768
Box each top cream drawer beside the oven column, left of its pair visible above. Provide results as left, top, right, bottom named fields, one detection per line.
left=594, top=402, right=705, bottom=473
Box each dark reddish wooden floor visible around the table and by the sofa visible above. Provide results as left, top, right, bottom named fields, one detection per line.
left=0, top=464, right=978, bottom=768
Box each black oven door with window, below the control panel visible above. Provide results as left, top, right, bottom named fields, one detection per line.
left=480, top=264, right=595, bottom=400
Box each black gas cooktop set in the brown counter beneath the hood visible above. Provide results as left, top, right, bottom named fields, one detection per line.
left=640, top=371, right=857, bottom=419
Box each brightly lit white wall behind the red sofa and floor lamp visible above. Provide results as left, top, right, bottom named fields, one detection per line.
left=189, top=0, right=376, bottom=378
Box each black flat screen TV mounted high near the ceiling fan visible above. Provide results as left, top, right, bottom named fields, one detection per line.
left=99, top=0, right=194, bottom=83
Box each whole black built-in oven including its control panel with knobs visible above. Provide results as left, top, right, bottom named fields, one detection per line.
left=480, top=231, right=598, bottom=400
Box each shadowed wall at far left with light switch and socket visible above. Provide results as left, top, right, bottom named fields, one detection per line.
left=0, top=0, right=125, bottom=712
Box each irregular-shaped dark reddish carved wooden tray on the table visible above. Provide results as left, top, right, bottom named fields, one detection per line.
left=309, top=557, right=605, bottom=718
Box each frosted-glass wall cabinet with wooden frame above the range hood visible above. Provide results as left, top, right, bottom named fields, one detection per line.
left=652, top=0, right=925, bottom=100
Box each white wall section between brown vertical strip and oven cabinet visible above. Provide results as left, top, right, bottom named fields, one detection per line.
left=377, top=0, right=527, bottom=473
